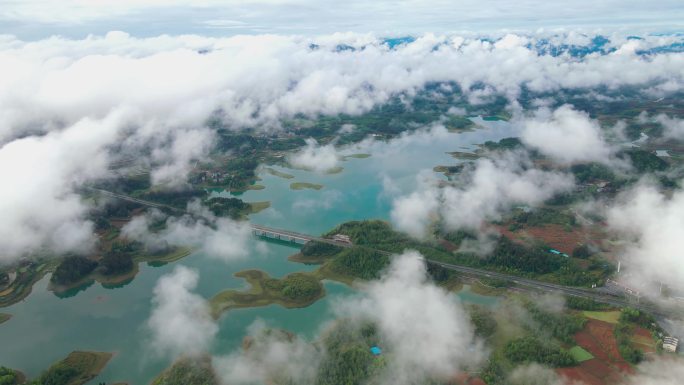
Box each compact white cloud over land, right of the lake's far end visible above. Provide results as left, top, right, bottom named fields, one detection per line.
left=521, top=105, right=614, bottom=164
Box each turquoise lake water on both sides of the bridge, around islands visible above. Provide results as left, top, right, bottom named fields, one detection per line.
left=0, top=118, right=514, bottom=385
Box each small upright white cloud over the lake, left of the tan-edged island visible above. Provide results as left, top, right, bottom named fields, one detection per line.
left=147, top=266, right=218, bottom=357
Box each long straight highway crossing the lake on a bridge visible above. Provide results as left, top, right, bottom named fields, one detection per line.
left=87, top=187, right=684, bottom=318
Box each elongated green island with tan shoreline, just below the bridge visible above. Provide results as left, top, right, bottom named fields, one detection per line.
left=210, top=270, right=325, bottom=318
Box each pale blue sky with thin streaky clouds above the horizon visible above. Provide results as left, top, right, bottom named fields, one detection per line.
left=0, top=0, right=684, bottom=39
